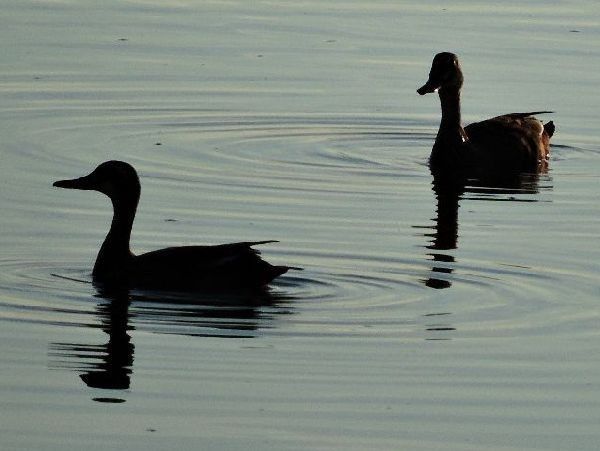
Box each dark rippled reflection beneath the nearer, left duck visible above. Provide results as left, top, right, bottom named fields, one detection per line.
left=50, top=286, right=291, bottom=402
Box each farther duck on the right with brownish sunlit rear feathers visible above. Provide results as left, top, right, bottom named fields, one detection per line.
left=417, top=52, right=554, bottom=174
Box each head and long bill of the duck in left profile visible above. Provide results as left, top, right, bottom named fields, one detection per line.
left=52, top=160, right=140, bottom=204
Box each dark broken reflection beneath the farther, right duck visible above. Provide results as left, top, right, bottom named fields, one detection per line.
left=423, top=172, right=539, bottom=289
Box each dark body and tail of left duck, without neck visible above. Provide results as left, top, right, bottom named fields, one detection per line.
left=130, top=241, right=290, bottom=289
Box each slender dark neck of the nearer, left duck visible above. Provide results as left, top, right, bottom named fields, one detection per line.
left=92, top=198, right=138, bottom=278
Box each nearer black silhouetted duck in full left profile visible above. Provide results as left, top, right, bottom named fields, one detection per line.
left=54, top=161, right=297, bottom=290
